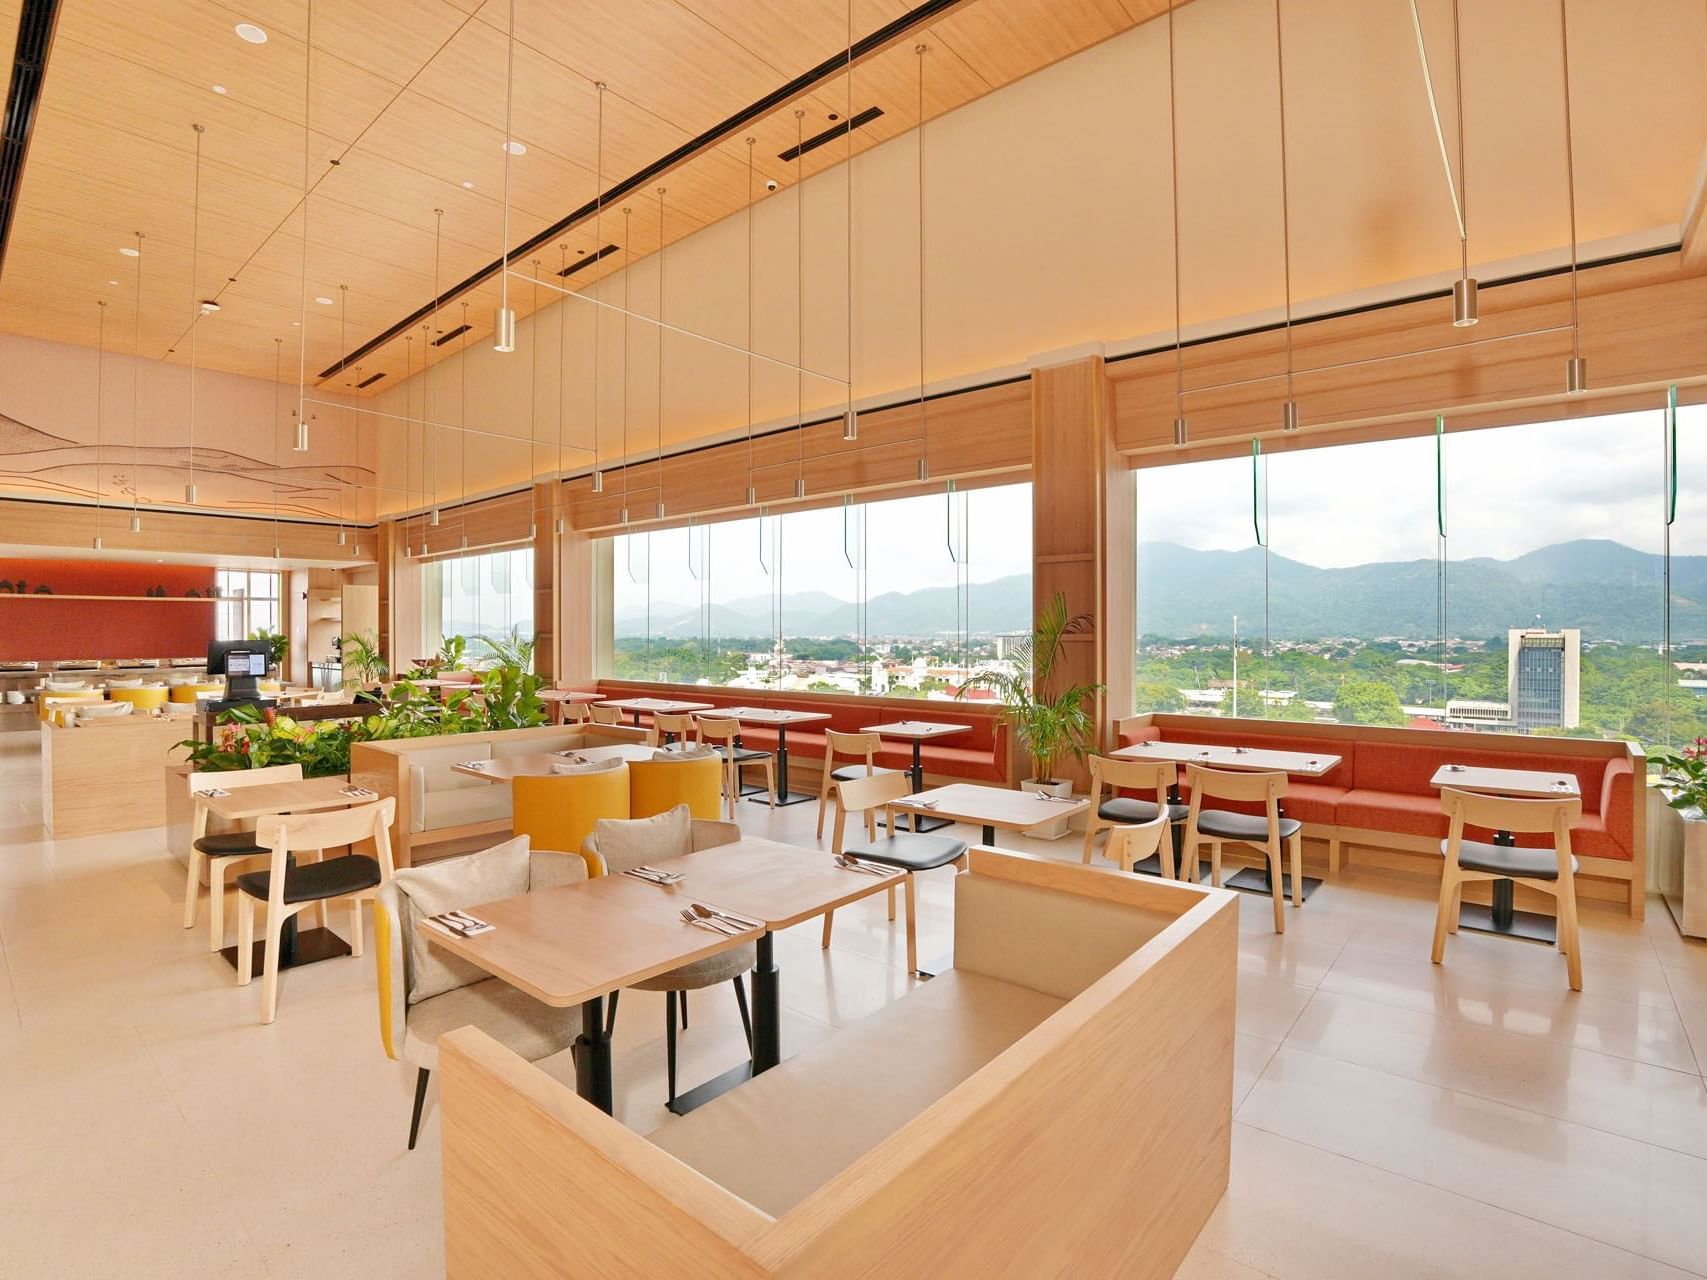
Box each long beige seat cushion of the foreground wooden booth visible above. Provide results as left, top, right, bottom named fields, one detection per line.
left=649, top=969, right=1063, bottom=1217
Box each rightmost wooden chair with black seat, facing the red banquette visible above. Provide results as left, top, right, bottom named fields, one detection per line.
left=1432, top=787, right=1582, bottom=992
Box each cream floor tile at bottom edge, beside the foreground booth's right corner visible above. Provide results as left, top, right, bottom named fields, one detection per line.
left=1195, top=1123, right=1693, bottom=1280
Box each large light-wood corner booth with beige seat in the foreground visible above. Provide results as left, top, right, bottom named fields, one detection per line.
left=439, top=848, right=1238, bottom=1280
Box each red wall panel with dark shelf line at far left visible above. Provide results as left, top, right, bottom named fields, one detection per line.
left=0, top=560, right=218, bottom=662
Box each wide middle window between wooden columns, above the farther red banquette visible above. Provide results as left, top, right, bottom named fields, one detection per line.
left=608, top=485, right=1031, bottom=698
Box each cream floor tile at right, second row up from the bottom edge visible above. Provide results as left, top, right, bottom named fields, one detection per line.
left=1234, top=1046, right=1707, bottom=1268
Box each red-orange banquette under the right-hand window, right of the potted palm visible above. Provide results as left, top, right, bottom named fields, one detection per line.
left=1111, top=712, right=1647, bottom=918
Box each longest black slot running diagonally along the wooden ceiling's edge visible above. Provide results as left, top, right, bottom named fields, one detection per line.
left=319, top=0, right=964, bottom=377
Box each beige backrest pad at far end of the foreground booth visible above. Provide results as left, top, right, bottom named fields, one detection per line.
left=954, top=876, right=1174, bottom=1000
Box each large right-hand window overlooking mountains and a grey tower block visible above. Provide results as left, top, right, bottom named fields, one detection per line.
left=1135, top=403, right=1707, bottom=744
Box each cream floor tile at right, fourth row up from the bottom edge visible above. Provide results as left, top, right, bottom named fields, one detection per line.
left=1321, top=944, right=1695, bottom=1072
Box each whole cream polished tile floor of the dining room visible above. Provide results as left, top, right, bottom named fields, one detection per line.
left=0, top=734, right=1707, bottom=1280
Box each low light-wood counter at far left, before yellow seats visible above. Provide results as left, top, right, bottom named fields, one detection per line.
left=39, top=715, right=191, bottom=840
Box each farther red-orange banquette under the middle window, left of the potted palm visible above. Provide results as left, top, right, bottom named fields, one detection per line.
left=572, top=679, right=1012, bottom=788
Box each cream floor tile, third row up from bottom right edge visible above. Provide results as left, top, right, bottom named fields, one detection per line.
left=1287, top=992, right=1707, bottom=1159
